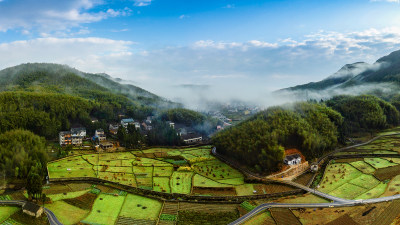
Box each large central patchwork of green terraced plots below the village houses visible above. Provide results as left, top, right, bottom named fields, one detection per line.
left=48, top=146, right=256, bottom=195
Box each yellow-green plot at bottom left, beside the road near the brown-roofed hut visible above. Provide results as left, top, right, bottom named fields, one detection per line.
left=46, top=201, right=89, bottom=225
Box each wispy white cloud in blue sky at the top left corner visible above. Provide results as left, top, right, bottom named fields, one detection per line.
left=0, top=0, right=132, bottom=33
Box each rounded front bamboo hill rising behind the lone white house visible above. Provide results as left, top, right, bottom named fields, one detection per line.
left=213, top=102, right=343, bottom=172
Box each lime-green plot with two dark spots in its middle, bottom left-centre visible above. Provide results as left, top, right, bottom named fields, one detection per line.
left=119, top=194, right=162, bottom=220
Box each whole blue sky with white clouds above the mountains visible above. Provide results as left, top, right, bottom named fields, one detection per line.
left=0, top=0, right=400, bottom=108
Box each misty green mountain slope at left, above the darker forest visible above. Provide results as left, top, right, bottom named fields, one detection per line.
left=0, top=63, right=179, bottom=108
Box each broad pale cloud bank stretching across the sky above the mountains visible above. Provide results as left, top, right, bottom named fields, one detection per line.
left=0, top=28, right=400, bottom=108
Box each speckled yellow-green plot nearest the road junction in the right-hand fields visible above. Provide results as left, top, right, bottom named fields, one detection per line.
left=318, top=163, right=363, bottom=193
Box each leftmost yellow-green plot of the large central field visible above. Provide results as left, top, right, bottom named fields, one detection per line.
left=47, top=156, right=96, bottom=178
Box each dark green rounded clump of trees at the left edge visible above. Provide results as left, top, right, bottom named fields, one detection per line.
left=0, top=130, right=47, bottom=178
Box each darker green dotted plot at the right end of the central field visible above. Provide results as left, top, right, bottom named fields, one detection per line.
left=192, top=160, right=244, bottom=184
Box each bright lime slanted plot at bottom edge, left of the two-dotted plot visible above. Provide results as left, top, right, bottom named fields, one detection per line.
left=82, top=194, right=125, bottom=224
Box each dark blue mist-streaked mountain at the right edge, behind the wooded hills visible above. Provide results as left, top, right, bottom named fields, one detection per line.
left=279, top=51, right=400, bottom=94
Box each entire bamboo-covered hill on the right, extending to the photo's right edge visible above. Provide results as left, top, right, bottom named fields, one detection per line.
left=213, top=95, right=400, bottom=173
